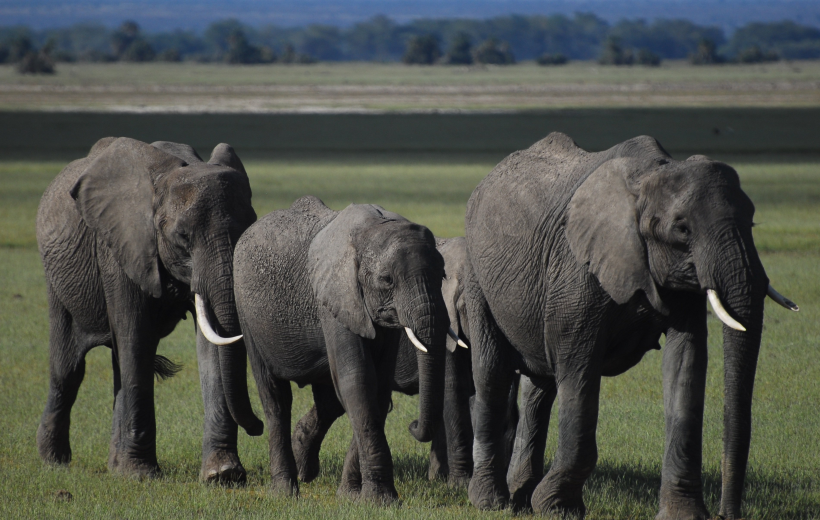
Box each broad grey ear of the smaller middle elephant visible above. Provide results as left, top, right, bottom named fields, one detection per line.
left=308, top=205, right=376, bottom=339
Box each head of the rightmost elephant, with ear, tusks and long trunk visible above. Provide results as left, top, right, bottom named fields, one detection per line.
left=565, top=137, right=797, bottom=518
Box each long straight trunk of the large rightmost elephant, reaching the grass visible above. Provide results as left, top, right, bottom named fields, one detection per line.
left=696, top=229, right=769, bottom=518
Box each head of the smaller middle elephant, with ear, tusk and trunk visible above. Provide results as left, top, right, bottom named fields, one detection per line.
left=308, top=205, right=449, bottom=442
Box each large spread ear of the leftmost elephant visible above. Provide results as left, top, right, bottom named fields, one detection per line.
left=69, top=137, right=185, bottom=298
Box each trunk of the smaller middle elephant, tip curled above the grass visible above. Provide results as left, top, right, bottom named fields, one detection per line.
left=399, top=277, right=450, bottom=442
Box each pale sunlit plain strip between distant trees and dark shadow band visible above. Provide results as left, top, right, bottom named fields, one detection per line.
left=0, top=61, right=820, bottom=112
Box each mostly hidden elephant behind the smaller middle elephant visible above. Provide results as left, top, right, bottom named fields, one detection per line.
left=292, top=237, right=518, bottom=487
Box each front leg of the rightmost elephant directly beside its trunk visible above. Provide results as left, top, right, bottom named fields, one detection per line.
left=656, top=295, right=711, bottom=520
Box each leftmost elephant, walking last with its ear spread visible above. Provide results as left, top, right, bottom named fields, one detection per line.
left=37, top=137, right=262, bottom=481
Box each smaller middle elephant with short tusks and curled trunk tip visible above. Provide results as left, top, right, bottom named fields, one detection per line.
left=234, top=197, right=449, bottom=503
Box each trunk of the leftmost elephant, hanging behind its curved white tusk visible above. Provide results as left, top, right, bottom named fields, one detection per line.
left=192, top=242, right=263, bottom=436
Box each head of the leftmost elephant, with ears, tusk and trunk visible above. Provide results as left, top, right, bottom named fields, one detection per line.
left=70, top=138, right=262, bottom=435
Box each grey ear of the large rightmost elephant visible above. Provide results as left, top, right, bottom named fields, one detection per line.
left=565, top=158, right=668, bottom=315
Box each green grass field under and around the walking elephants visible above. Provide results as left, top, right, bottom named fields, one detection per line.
left=0, top=150, right=820, bottom=520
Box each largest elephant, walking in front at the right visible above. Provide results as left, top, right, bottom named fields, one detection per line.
left=466, top=133, right=768, bottom=519
